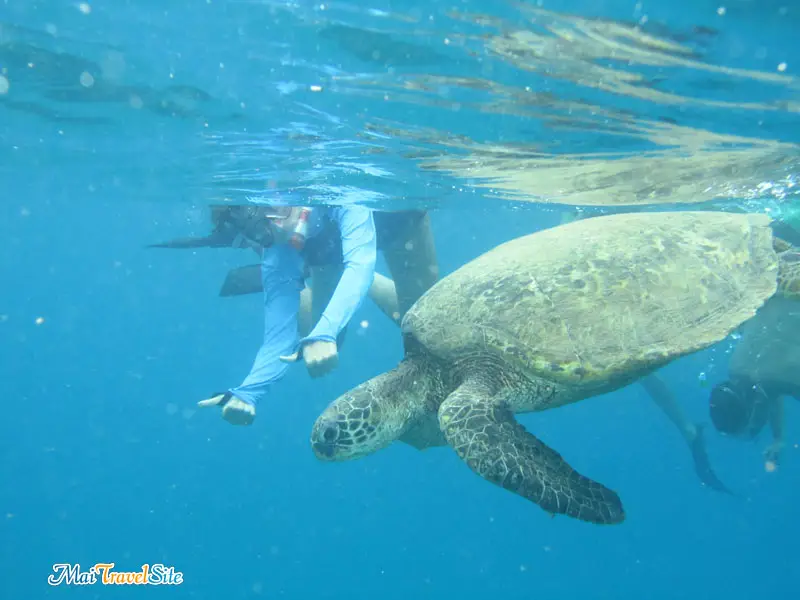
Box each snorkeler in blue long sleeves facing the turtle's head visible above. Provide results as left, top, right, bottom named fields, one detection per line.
left=152, top=206, right=438, bottom=425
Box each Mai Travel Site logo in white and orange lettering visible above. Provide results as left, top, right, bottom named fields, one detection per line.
left=47, top=563, right=183, bottom=585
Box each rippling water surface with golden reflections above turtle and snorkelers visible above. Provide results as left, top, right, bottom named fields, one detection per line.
left=0, top=0, right=800, bottom=213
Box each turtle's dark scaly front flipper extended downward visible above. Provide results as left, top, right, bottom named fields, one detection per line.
left=439, top=381, right=625, bottom=525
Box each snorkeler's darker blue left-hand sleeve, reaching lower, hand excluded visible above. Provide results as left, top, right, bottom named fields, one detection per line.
left=229, top=244, right=310, bottom=405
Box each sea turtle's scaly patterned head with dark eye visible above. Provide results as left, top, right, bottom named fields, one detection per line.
left=311, top=360, right=438, bottom=461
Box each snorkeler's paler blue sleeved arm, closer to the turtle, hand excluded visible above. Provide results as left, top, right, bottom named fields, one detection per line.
left=301, top=206, right=377, bottom=344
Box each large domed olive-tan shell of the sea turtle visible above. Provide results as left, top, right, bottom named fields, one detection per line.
left=403, top=211, right=778, bottom=386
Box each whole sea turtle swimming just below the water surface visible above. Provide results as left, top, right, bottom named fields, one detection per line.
left=311, top=211, right=800, bottom=524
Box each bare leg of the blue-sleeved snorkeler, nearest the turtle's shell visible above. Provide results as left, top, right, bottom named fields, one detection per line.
left=370, top=211, right=439, bottom=323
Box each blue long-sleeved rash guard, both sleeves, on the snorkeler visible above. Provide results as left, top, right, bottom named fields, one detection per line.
left=229, top=206, right=377, bottom=405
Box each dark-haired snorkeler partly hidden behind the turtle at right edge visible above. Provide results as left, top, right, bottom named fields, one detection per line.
left=709, top=297, right=800, bottom=471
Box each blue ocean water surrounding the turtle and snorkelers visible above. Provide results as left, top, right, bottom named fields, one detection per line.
left=0, top=0, right=800, bottom=600
